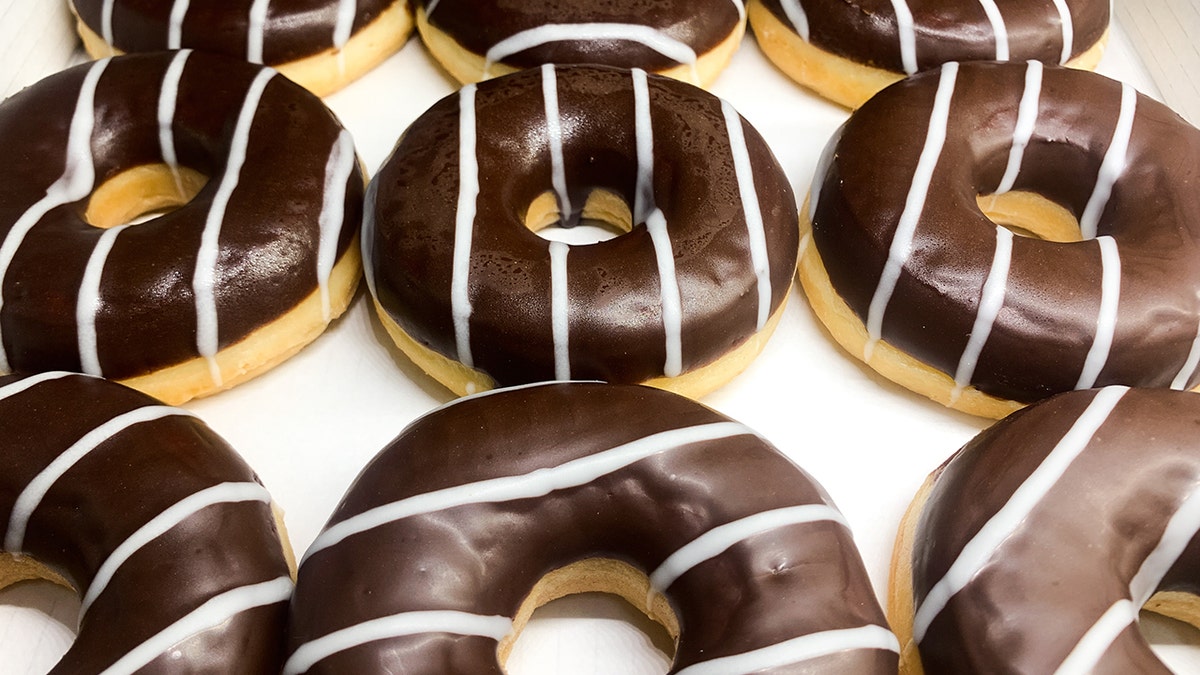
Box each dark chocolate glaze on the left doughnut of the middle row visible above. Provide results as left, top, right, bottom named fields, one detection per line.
left=0, top=52, right=364, bottom=378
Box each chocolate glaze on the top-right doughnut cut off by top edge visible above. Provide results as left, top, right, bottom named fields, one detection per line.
left=756, top=0, right=1109, bottom=73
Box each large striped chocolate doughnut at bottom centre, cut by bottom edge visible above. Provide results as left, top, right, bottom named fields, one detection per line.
left=283, top=382, right=899, bottom=675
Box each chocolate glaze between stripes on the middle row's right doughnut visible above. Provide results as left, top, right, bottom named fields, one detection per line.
left=812, top=64, right=1200, bottom=402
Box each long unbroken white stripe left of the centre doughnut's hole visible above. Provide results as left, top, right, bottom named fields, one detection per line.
left=450, top=84, right=479, bottom=368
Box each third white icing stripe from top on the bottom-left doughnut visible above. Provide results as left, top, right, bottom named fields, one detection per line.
left=79, top=483, right=271, bottom=619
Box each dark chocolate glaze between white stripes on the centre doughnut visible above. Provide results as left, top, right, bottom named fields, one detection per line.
left=364, top=66, right=798, bottom=386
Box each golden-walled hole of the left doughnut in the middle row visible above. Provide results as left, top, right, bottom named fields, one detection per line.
left=84, top=165, right=209, bottom=229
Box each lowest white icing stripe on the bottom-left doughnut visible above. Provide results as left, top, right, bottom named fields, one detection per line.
left=100, top=577, right=292, bottom=675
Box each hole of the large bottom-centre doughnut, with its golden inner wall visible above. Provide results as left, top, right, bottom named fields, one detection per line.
left=496, top=558, right=679, bottom=675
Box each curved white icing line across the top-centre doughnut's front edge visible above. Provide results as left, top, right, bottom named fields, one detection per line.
left=484, top=23, right=700, bottom=82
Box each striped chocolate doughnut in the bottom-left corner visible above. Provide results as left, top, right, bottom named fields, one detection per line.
left=0, top=372, right=293, bottom=674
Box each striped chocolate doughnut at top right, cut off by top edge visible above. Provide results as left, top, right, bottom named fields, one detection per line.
left=748, top=0, right=1110, bottom=108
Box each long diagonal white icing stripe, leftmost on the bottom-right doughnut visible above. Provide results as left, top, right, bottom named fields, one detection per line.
left=912, top=387, right=1129, bottom=643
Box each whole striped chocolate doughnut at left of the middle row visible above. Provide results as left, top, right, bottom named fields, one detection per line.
left=0, top=50, right=365, bottom=404
